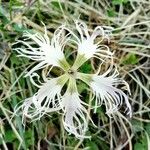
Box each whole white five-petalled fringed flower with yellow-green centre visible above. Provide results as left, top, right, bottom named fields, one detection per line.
left=15, top=21, right=131, bottom=139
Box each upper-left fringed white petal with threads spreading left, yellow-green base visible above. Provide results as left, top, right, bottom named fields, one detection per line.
left=14, top=26, right=69, bottom=76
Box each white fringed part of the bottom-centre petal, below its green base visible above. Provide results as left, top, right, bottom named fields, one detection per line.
left=61, top=92, right=89, bottom=138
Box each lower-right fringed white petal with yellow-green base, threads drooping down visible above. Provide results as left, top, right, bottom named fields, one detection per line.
left=78, top=68, right=132, bottom=117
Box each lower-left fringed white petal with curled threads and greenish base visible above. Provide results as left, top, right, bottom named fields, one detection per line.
left=17, top=76, right=67, bottom=119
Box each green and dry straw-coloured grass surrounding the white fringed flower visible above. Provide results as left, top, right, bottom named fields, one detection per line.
left=0, top=0, right=150, bottom=150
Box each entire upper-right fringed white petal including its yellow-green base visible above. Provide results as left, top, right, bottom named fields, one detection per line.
left=70, top=21, right=113, bottom=69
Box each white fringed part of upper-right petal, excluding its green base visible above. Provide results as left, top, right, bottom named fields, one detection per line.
left=75, top=21, right=113, bottom=59
